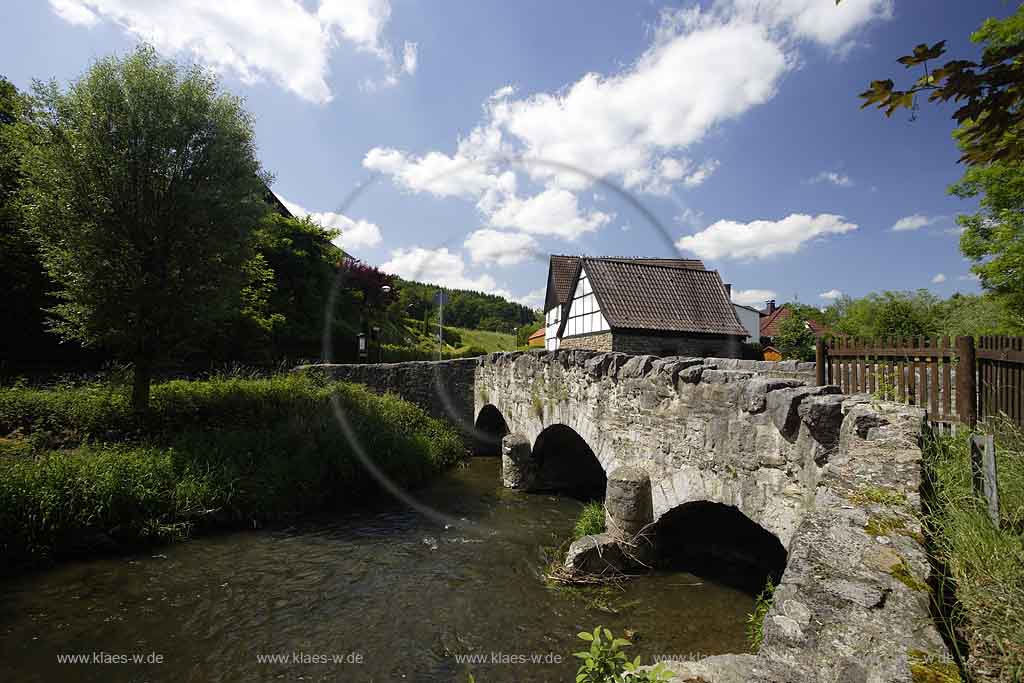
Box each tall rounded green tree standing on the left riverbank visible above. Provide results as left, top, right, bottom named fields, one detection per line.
left=22, top=46, right=268, bottom=410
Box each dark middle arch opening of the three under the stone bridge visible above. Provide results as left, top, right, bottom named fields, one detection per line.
left=534, top=423, right=608, bottom=501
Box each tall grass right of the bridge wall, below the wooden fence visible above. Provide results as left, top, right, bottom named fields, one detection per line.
left=926, top=420, right=1024, bottom=683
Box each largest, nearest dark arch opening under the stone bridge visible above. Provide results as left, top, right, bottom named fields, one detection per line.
left=653, top=501, right=787, bottom=594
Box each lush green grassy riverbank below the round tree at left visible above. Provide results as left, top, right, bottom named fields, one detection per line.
left=0, top=375, right=465, bottom=568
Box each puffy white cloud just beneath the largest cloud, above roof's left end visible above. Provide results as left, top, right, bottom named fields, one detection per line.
left=489, top=189, right=613, bottom=240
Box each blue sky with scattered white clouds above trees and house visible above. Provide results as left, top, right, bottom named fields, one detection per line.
left=0, top=0, right=1016, bottom=306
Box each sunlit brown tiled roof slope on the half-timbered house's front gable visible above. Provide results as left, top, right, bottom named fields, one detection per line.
left=583, top=257, right=746, bottom=337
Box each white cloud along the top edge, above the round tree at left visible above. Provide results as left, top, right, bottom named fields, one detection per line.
left=50, top=0, right=415, bottom=103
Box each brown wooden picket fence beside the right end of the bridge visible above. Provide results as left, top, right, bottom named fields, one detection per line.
left=816, top=337, right=1024, bottom=426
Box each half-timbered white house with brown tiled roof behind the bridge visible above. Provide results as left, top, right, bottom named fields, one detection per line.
left=544, top=255, right=749, bottom=357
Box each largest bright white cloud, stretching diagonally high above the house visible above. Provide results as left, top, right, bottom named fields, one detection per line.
left=488, top=11, right=788, bottom=190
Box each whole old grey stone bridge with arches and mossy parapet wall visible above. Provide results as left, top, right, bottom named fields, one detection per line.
left=305, top=350, right=949, bottom=683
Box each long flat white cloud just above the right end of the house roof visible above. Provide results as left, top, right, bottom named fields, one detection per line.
left=676, top=213, right=857, bottom=259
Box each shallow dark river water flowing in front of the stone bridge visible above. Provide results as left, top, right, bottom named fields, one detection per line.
left=0, top=458, right=754, bottom=683
